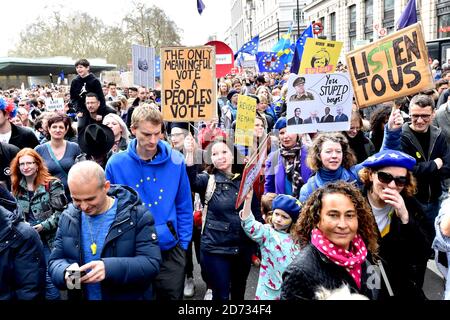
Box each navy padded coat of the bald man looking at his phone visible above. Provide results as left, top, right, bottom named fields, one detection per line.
left=49, top=185, right=161, bottom=300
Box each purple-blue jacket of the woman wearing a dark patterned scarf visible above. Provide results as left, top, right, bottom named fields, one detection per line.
left=264, top=146, right=312, bottom=194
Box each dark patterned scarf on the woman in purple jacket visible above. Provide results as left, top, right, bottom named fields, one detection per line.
left=280, top=142, right=303, bottom=198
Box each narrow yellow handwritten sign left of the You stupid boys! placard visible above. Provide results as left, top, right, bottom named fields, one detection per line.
left=234, top=95, right=256, bottom=147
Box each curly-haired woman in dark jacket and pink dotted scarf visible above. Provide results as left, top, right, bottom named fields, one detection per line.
left=281, top=181, right=381, bottom=300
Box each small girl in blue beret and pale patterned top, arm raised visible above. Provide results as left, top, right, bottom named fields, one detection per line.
left=240, top=191, right=301, bottom=300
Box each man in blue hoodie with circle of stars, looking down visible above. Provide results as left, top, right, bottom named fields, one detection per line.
left=106, top=105, right=193, bottom=300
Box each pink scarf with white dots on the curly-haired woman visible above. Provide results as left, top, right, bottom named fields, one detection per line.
left=311, top=228, right=367, bottom=289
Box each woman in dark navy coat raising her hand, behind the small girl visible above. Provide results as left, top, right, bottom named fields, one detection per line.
left=185, top=136, right=262, bottom=301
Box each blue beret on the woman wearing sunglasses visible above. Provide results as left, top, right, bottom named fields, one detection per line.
left=362, top=149, right=416, bottom=170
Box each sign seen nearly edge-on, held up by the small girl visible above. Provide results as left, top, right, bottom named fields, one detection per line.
left=235, top=135, right=269, bottom=209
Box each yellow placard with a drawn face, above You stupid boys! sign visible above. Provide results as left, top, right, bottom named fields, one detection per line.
left=298, top=38, right=342, bottom=74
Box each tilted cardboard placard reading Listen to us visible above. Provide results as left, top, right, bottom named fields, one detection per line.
left=346, top=22, right=434, bottom=108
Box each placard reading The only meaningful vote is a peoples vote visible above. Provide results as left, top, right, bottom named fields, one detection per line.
left=161, top=46, right=217, bottom=121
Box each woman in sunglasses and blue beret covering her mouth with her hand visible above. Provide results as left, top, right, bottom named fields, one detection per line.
left=359, top=150, right=432, bottom=300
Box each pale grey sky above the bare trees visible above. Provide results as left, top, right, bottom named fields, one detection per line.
left=0, top=0, right=230, bottom=57
